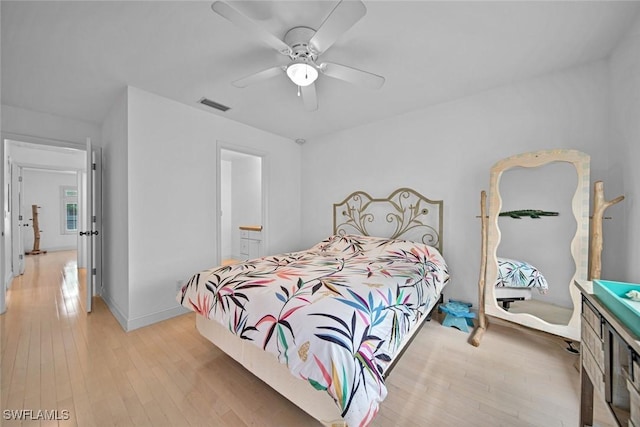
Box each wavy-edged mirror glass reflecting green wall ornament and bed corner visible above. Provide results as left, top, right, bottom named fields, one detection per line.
left=495, top=162, right=578, bottom=325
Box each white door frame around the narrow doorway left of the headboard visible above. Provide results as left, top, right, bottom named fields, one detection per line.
left=215, top=141, right=269, bottom=265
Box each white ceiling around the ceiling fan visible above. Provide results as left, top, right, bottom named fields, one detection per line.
left=1, top=0, right=640, bottom=140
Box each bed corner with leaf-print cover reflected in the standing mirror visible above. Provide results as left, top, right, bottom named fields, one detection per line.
left=494, top=257, right=549, bottom=310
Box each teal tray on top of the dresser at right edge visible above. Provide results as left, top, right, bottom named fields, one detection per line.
left=593, top=279, right=640, bottom=337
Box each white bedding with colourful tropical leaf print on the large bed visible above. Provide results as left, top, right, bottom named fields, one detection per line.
left=177, top=235, right=449, bottom=426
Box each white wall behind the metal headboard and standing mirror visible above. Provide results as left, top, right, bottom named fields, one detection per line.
left=302, top=62, right=608, bottom=304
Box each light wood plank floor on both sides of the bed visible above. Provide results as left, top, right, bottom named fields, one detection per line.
left=0, top=252, right=608, bottom=427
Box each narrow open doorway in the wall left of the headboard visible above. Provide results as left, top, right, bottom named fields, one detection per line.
left=218, top=147, right=266, bottom=265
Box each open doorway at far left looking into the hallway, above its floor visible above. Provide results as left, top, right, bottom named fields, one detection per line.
left=0, top=137, right=93, bottom=312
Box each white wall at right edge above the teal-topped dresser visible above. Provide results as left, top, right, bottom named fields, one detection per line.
left=602, top=18, right=640, bottom=283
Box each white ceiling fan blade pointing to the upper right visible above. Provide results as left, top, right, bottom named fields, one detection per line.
left=309, top=0, right=367, bottom=54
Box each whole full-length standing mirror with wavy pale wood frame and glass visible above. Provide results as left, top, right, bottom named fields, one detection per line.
left=485, top=150, right=589, bottom=340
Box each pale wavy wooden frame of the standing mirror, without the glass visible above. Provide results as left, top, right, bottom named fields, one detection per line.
left=485, top=150, right=590, bottom=341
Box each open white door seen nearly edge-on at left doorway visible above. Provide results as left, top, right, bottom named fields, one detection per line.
left=78, top=138, right=101, bottom=313
